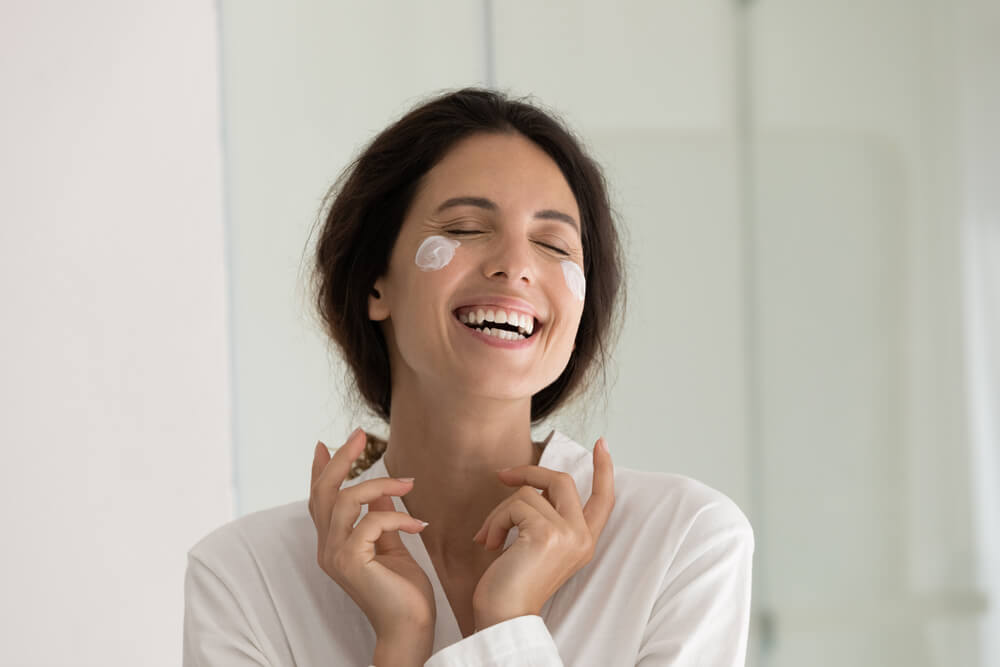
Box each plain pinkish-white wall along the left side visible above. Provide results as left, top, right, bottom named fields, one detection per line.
left=0, top=0, right=232, bottom=667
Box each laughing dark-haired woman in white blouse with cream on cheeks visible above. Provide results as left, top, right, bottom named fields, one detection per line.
left=185, top=89, right=753, bottom=667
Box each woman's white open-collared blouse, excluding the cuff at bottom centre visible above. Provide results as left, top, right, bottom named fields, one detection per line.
left=184, top=431, right=754, bottom=667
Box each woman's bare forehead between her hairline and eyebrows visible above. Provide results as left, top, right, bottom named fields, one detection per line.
left=417, top=134, right=580, bottom=220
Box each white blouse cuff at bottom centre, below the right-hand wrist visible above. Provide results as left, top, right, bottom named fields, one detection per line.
left=424, top=615, right=563, bottom=667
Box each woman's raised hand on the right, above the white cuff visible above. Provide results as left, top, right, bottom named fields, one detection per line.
left=472, top=438, right=615, bottom=630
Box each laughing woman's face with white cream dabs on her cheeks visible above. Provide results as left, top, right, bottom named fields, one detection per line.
left=369, top=134, right=584, bottom=399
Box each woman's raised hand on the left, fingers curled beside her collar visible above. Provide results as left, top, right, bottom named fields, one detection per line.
left=309, top=428, right=437, bottom=640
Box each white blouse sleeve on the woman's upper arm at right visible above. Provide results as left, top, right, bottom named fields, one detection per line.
left=636, top=499, right=754, bottom=667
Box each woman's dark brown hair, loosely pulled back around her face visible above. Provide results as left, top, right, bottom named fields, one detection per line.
left=312, top=88, right=625, bottom=479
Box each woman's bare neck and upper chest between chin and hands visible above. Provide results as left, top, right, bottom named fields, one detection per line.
left=383, top=378, right=542, bottom=568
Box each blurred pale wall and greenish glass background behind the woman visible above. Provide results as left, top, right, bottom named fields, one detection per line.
left=0, top=0, right=1000, bottom=667
